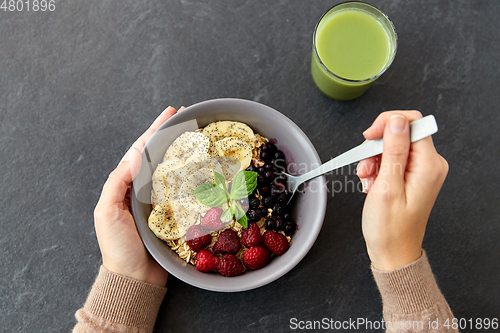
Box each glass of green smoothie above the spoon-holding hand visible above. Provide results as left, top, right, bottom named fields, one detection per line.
left=311, top=1, right=398, bottom=101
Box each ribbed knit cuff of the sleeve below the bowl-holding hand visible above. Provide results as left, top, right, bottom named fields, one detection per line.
left=83, top=266, right=167, bottom=331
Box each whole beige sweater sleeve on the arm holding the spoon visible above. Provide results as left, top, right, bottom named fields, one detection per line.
left=372, top=252, right=458, bottom=333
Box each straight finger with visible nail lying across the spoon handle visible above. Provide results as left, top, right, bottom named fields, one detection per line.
left=374, top=114, right=410, bottom=191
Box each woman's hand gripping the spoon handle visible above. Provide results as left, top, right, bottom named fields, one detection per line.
left=357, top=111, right=448, bottom=271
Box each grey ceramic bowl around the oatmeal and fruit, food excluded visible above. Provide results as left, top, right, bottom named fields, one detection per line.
left=131, top=98, right=327, bottom=292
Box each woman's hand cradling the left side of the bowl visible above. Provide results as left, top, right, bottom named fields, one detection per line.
left=94, top=107, right=177, bottom=286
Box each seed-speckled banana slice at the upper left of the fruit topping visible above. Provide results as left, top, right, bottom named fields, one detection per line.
left=163, top=132, right=210, bottom=162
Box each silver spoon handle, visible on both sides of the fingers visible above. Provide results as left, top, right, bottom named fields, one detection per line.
left=297, top=115, right=438, bottom=183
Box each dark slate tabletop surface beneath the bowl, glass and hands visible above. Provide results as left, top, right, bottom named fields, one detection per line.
left=0, top=0, right=500, bottom=332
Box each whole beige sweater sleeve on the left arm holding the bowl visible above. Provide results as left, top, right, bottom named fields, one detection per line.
left=73, top=266, right=167, bottom=333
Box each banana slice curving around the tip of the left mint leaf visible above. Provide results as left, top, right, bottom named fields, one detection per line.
left=179, top=168, right=214, bottom=214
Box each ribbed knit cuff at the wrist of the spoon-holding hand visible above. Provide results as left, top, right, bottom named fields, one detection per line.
left=372, top=251, right=446, bottom=314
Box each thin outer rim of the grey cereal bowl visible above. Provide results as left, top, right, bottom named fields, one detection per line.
left=130, top=98, right=327, bottom=292
